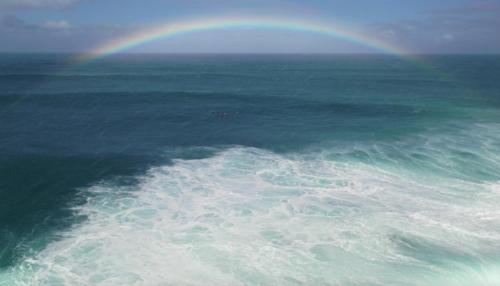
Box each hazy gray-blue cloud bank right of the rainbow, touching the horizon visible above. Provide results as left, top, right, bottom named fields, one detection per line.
left=369, top=0, right=500, bottom=53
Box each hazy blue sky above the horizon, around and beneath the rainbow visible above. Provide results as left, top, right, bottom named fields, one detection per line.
left=0, top=0, right=500, bottom=54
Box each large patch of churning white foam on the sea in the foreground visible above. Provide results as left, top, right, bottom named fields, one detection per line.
left=2, top=147, right=500, bottom=286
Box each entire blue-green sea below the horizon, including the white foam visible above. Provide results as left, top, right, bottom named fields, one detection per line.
left=0, top=54, right=500, bottom=286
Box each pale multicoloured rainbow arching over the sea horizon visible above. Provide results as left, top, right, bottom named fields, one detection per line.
left=79, top=17, right=414, bottom=61
